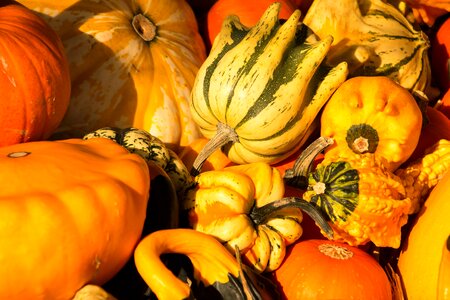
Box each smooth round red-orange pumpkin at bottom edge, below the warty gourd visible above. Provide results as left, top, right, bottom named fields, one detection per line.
left=274, top=239, right=392, bottom=300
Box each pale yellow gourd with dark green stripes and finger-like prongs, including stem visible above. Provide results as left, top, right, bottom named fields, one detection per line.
left=191, top=3, right=347, bottom=173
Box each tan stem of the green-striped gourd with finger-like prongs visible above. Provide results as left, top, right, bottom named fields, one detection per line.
left=191, top=122, right=239, bottom=176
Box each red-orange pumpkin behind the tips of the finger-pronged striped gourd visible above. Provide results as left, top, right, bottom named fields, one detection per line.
left=206, top=0, right=295, bottom=46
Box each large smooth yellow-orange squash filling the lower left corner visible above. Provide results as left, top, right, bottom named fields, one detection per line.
left=0, top=139, right=150, bottom=300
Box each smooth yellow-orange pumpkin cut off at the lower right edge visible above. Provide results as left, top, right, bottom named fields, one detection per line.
left=398, top=173, right=450, bottom=300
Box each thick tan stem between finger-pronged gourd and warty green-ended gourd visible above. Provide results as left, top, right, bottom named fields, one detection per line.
left=284, top=136, right=334, bottom=189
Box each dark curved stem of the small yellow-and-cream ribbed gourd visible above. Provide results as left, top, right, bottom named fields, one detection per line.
left=250, top=197, right=333, bottom=238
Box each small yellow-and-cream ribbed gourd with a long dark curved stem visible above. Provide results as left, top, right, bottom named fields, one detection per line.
left=186, top=162, right=331, bottom=272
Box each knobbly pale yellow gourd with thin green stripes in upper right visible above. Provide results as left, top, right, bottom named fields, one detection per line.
left=303, top=0, right=431, bottom=93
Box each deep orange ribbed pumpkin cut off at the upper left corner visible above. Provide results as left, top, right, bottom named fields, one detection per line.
left=0, top=1, right=71, bottom=146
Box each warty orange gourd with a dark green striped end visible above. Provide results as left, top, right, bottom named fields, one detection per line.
left=303, top=153, right=411, bottom=248
